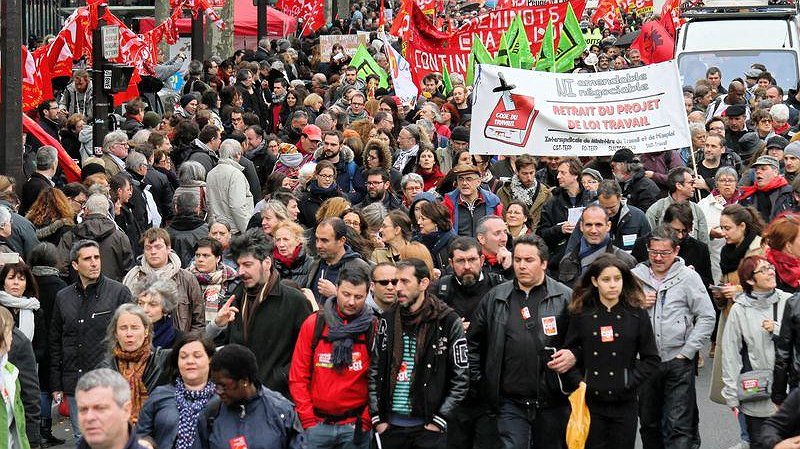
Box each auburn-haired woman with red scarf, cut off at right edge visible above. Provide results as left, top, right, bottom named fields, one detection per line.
left=764, top=213, right=800, bottom=293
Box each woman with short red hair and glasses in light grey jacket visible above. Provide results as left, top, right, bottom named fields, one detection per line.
left=721, top=256, right=791, bottom=449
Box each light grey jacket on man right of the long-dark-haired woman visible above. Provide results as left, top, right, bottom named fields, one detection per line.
left=632, top=257, right=716, bottom=362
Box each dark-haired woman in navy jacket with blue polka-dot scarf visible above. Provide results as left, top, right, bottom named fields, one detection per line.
left=136, top=334, right=217, bottom=449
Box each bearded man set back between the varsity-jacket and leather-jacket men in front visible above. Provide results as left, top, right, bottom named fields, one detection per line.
left=428, top=237, right=505, bottom=449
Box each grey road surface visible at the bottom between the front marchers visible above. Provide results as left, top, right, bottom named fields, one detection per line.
left=48, top=344, right=739, bottom=449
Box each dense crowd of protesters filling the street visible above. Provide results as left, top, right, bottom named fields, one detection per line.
left=7, top=5, right=800, bottom=449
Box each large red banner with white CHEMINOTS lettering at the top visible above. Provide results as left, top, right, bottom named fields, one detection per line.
left=399, top=0, right=586, bottom=85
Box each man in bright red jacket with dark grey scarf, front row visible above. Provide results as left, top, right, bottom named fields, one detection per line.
left=289, top=266, right=378, bottom=449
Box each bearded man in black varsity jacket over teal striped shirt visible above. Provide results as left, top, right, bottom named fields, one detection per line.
left=369, top=258, right=469, bottom=449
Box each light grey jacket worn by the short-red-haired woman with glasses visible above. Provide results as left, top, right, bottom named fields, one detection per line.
left=722, top=290, right=791, bottom=418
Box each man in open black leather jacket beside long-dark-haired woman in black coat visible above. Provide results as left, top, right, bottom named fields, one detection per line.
left=467, top=235, right=580, bottom=449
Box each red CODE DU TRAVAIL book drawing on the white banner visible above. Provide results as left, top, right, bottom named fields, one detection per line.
left=483, top=91, right=539, bottom=147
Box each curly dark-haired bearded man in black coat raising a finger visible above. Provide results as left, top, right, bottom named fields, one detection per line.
left=212, top=229, right=311, bottom=397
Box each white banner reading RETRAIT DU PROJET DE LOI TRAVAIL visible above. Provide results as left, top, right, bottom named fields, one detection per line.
left=470, top=61, right=691, bottom=156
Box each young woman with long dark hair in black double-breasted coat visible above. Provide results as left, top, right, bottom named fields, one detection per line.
left=565, top=254, right=661, bottom=449
